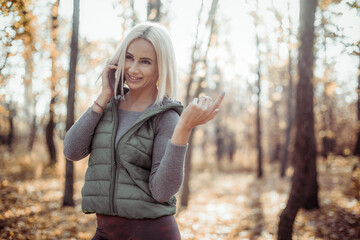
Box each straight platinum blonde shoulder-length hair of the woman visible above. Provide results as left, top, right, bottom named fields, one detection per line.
left=103, top=22, right=178, bottom=104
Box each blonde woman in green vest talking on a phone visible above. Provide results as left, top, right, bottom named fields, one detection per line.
left=64, top=23, right=224, bottom=240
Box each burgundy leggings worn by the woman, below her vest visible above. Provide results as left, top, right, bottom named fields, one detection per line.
left=92, top=214, right=181, bottom=240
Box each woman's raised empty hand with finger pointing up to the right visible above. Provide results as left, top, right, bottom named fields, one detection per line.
left=179, top=92, right=225, bottom=131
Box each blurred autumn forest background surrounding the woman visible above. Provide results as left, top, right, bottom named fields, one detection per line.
left=0, top=0, right=360, bottom=239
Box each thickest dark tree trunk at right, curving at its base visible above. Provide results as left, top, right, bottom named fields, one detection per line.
left=278, top=0, right=319, bottom=239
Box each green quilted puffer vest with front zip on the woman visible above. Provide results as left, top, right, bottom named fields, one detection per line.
left=81, top=98, right=183, bottom=219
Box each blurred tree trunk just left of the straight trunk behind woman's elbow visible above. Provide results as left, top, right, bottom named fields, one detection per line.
left=45, top=0, right=60, bottom=166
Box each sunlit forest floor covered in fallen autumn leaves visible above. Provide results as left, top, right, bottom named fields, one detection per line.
left=0, top=150, right=360, bottom=240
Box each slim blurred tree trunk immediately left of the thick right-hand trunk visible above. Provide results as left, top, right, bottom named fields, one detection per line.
left=280, top=3, right=293, bottom=178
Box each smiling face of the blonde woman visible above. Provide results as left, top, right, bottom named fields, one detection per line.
left=124, top=38, right=159, bottom=94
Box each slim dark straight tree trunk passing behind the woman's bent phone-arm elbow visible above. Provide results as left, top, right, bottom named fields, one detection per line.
left=63, top=0, right=80, bottom=206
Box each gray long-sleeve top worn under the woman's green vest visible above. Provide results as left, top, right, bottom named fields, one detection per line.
left=64, top=108, right=187, bottom=202
